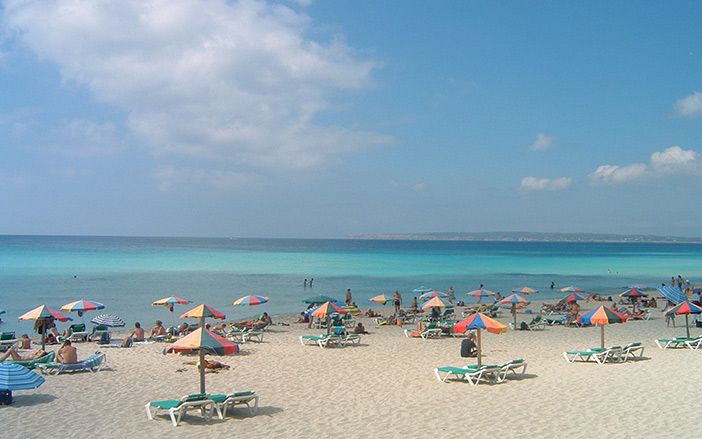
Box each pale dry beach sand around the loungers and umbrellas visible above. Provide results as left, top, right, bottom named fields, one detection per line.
left=0, top=304, right=702, bottom=438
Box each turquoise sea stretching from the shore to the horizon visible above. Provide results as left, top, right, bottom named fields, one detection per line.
left=0, top=235, right=702, bottom=332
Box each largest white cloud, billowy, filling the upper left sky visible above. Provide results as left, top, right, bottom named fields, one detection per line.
left=2, top=0, right=392, bottom=168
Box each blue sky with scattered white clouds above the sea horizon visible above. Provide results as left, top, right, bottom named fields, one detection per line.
left=0, top=0, right=702, bottom=238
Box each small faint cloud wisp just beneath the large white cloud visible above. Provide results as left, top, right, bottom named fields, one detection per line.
left=156, top=165, right=256, bottom=192
